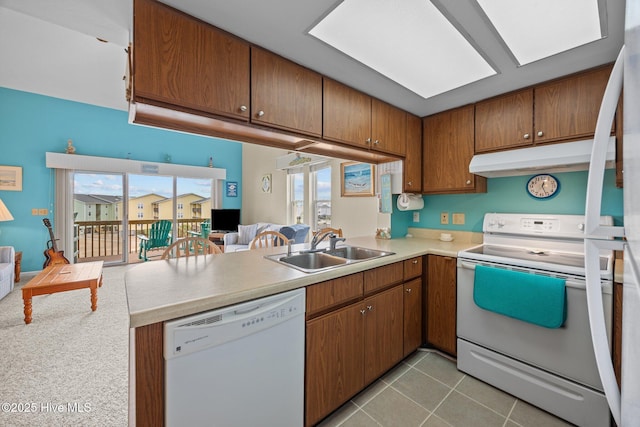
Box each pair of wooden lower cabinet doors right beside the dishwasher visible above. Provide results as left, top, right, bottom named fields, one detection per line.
left=305, top=285, right=404, bottom=426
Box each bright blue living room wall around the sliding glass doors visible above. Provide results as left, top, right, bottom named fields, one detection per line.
left=0, top=87, right=242, bottom=271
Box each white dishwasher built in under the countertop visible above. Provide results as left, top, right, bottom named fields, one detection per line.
left=164, top=288, right=305, bottom=427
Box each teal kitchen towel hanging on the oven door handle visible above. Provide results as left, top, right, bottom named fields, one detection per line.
left=473, top=265, right=566, bottom=328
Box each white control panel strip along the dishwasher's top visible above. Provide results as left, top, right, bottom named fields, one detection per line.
left=164, top=288, right=305, bottom=360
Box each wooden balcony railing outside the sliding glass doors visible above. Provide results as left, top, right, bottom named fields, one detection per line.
left=74, top=218, right=208, bottom=262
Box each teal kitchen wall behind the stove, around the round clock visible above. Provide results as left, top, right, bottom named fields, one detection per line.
left=391, top=170, right=624, bottom=237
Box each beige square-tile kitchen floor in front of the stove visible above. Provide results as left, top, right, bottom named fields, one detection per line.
left=320, top=351, right=571, bottom=427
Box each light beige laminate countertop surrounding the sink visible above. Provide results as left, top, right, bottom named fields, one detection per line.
left=125, top=228, right=482, bottom=328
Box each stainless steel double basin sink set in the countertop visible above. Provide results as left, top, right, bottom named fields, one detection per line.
left=265, top=246, right=395, bottom=273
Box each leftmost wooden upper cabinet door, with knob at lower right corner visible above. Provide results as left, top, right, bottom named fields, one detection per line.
left=133, top=0, right=250, bottom=120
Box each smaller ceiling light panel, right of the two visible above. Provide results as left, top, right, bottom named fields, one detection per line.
left=477, top=0, right=602, bottom=65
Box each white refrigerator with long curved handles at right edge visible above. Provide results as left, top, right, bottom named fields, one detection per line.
left=585, top=0, right=640, bottom=427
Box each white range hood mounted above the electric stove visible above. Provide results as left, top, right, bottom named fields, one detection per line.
left=469, top=137, right=616, bottom=178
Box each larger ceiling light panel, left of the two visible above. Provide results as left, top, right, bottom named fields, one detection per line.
left=309, top=0, right=496, bottom=98
